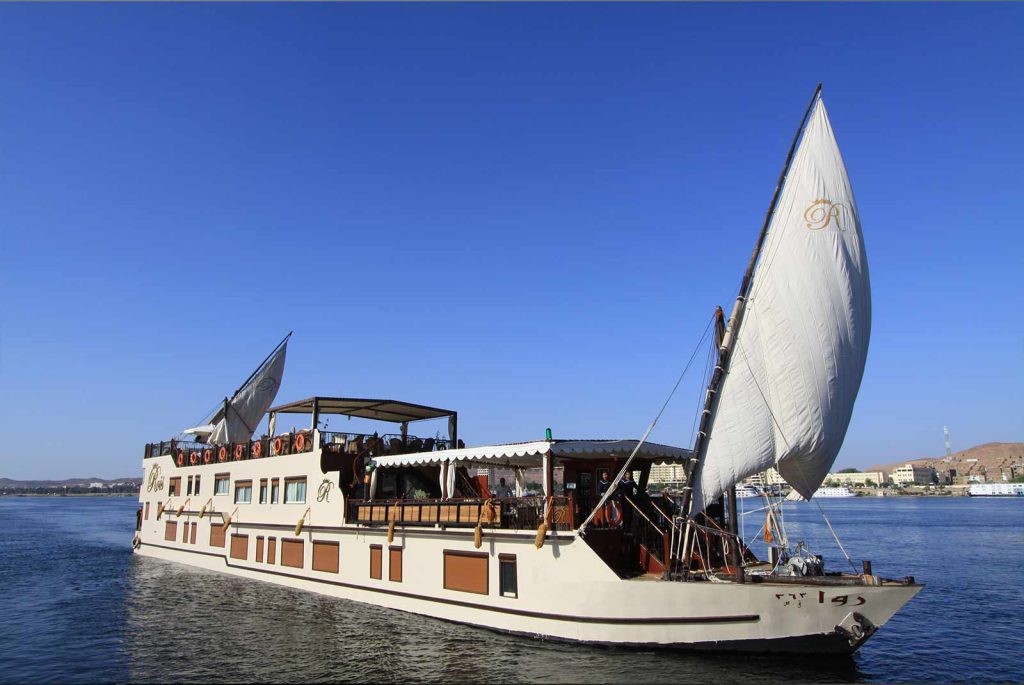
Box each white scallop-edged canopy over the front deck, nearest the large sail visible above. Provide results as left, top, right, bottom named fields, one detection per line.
left=374, top=440, right=693, bottom=468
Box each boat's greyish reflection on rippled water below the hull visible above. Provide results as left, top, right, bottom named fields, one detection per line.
left=124, top=556, right=866, bottom=684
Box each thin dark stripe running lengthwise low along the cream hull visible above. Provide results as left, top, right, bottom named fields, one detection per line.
left=139, top=543, right=761, bottom=626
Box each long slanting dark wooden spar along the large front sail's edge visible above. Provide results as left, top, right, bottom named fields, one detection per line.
left=681, top=83, right=821, bottom=577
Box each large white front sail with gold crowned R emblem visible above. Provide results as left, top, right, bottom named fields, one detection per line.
left=693, top=99, right=871, bottom=511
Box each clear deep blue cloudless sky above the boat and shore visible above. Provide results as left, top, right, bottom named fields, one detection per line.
left=0, top=3, right=1024, bottom=478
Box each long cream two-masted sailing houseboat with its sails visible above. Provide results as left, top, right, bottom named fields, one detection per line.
left=133, top=85, right=923, bottom=653
